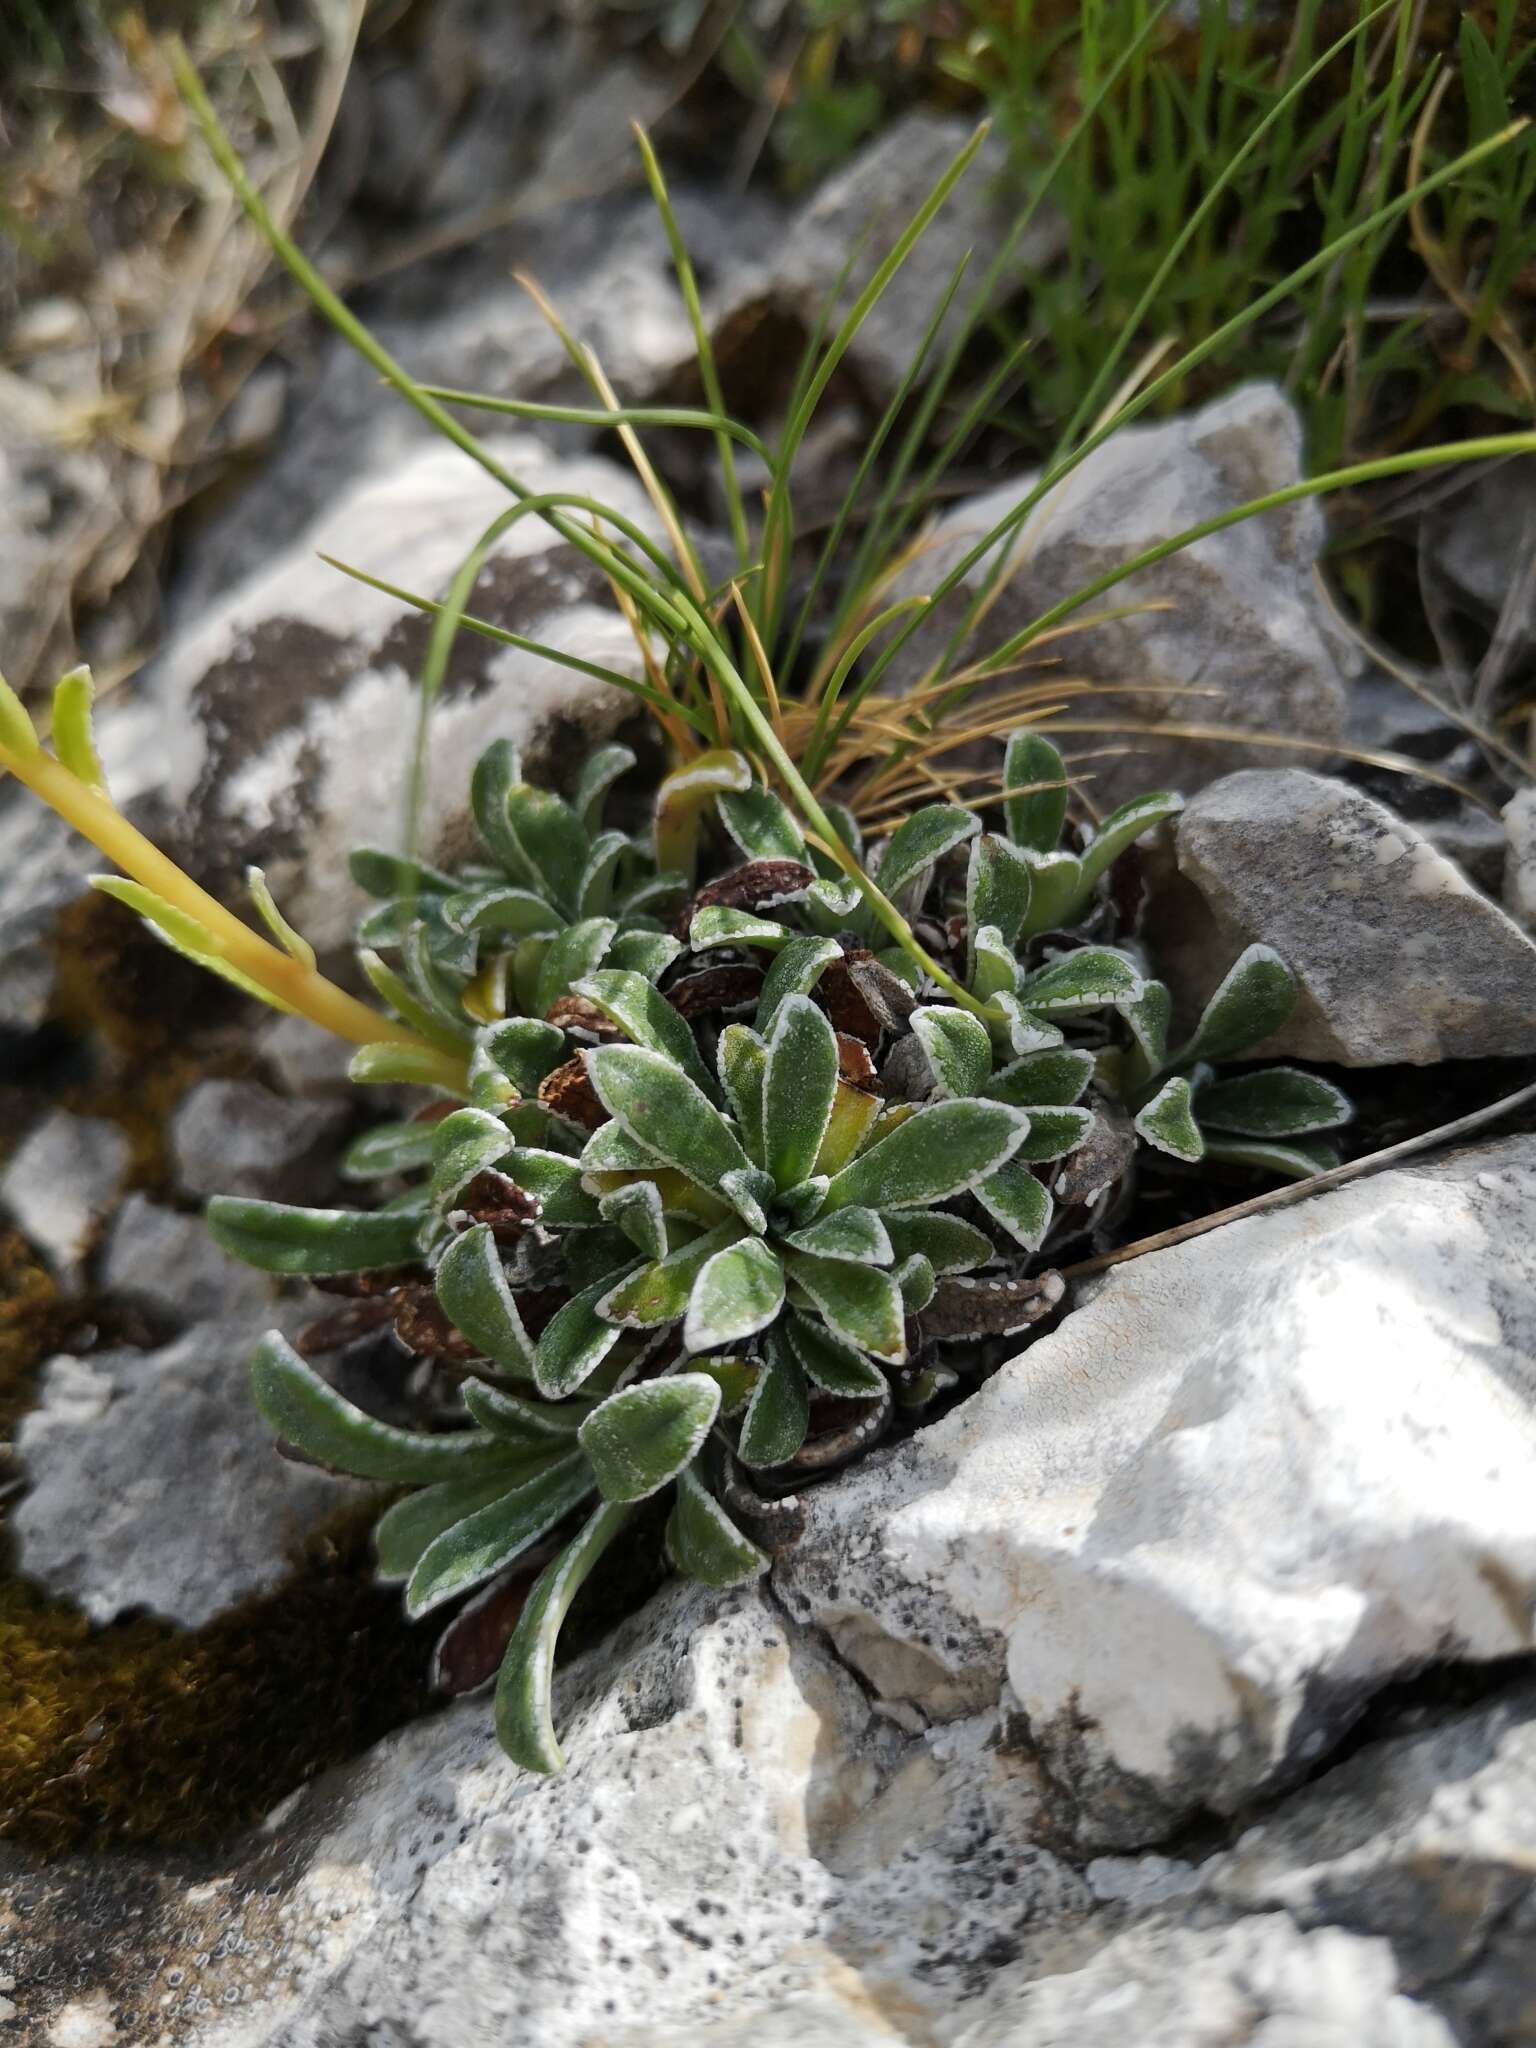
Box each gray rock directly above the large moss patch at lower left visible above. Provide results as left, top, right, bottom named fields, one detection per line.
left=12, top=1309, right=367, bottom=1628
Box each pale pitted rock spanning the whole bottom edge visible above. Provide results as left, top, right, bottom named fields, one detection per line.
left=12, top=1587, right=1536, bottom=2048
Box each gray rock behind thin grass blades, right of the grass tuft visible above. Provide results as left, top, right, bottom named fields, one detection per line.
left=889, top=383, right=1358, bottom=805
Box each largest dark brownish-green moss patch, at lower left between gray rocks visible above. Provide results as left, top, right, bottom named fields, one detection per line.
left=0, top=1501, right=436, bottom=1853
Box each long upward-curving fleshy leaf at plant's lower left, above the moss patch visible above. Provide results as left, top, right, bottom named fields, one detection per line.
left=250, top=1329, right=518, bottom=1485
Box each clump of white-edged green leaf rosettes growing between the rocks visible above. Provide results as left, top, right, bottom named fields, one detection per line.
left=195, top=735, right=1348, bottom=1769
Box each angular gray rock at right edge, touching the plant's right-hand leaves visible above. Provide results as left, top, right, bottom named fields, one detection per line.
left=1153, top=768, right=1536, bottom=1067
